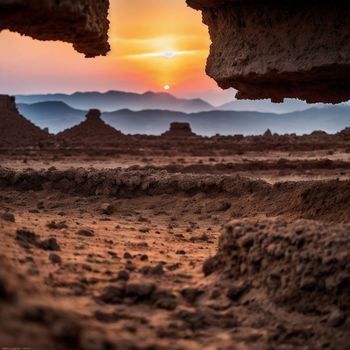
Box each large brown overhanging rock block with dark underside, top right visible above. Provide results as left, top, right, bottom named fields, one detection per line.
left=187, top=0, right=350, bottom=103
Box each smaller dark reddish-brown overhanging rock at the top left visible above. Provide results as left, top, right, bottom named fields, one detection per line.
left=0, top=0, right=110, bottom=57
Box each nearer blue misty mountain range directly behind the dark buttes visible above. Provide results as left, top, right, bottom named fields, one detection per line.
left=17, top=102, right=350, bottom=136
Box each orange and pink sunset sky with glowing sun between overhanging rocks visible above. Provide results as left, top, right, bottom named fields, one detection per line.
left=0, top=0, right=234, bottom=105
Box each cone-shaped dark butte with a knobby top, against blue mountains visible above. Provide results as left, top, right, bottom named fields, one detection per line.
left=57, top=109, right=124, bottom=145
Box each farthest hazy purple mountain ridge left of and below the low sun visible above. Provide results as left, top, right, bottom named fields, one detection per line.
left=16, top=91, right=213, bottom=113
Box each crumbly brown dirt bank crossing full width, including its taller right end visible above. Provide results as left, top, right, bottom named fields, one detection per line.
left=0, top=167, right=350, bottom=222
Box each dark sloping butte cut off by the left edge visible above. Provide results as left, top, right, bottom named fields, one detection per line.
left=0, top=95, right=49, bottom=147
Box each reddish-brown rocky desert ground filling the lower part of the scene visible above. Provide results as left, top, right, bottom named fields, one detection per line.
left=0, top=139, right=350, bottom=350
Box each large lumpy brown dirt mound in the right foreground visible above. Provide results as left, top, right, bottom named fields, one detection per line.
left=204, top=220, right=350, bottom=315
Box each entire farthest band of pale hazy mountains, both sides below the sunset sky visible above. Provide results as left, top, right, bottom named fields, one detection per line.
left=16, top=91, right=340, bottom=114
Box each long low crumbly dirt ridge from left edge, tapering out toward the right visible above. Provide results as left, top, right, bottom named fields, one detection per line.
left=0, top=167, right=269, bottom=196
